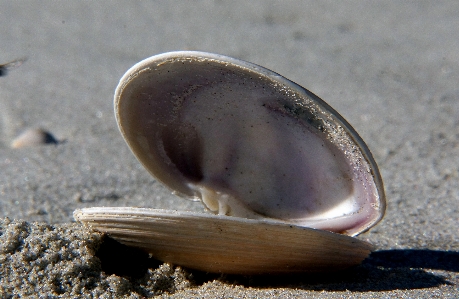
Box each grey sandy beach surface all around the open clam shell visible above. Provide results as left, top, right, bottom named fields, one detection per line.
left=0, top=0, right=459, bottom=298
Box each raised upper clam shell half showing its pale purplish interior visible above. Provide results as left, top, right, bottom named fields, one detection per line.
left=115, top=52, right=385, bottom=239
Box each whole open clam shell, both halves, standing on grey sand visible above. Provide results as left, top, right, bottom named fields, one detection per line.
left=75, top=52, right=385, bottom=273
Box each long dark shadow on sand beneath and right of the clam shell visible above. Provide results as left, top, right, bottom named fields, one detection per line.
left=212, top=249, right=459, bottom=292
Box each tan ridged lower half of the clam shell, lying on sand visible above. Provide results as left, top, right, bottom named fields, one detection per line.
left=74, top=207, right=373, bottom=275
